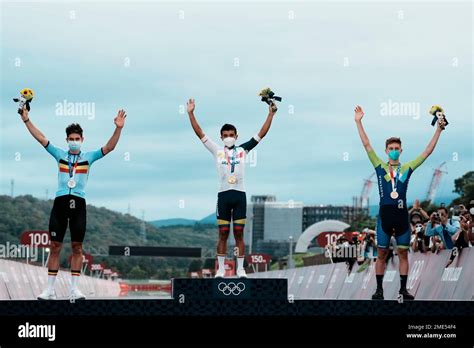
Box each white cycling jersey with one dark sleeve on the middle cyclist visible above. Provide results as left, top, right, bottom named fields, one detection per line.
left=201, top=135, right=261, bottom=192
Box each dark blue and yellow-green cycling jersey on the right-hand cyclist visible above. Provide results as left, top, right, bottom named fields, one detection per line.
left=367, top=150, right=426, bottom=207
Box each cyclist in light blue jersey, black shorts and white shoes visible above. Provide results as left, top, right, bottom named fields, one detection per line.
left=21, top=109, right=127, bottom=300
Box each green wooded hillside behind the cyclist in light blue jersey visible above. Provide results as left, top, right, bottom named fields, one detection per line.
left=0, top=195, right=217, bottom=279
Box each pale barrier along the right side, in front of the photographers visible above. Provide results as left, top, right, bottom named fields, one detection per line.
left=249, top=248, right=474, bottom=301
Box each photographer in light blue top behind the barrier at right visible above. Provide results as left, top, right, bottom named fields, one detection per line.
left=425, top=206, right=459, bottom=252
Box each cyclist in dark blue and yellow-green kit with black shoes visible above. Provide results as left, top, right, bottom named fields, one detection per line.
left=354, top=106, right=445, bottom=300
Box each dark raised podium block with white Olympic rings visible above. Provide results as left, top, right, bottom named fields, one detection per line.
left=171, top=278, right=288, bottom=301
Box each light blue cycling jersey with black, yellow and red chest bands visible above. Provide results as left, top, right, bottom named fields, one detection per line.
left=45, top=141, right=104, bottom=198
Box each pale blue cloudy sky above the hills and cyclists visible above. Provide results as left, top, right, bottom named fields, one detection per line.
left=0, top=1, right=474, bottom=220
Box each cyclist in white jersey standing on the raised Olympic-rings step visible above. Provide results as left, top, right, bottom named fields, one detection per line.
left=187, top=99, right=276, bottom=278
